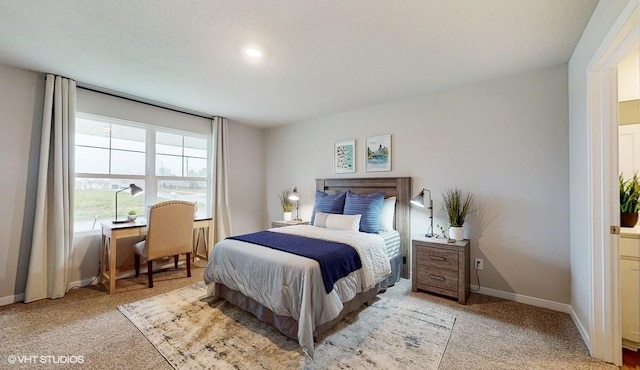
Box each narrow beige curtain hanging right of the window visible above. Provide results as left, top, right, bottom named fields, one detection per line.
left=211, top=117, right=231, bottom=250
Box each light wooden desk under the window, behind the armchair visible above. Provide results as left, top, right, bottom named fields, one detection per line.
left=100, top=217, right=213, bottom=293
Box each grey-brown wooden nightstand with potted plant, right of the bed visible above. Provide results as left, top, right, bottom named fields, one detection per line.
left=411, top=236, right=469, bottom=304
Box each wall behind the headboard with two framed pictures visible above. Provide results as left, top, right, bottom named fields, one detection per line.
left=265, top=65, right=570, bottom=303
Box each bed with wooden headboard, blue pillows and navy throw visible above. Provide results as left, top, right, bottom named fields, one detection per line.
left=204, top=177, right=411, bottom=356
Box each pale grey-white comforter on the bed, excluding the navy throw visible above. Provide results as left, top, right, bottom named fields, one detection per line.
left=204, top=225, right=391, bottom=356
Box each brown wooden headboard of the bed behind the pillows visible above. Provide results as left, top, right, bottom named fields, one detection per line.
left=316, top=177, right=411, bottom=279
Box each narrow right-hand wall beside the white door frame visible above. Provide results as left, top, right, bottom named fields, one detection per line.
left=569, top=0, right=633, bottom=352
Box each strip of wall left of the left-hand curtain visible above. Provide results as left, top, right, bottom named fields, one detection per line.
left=0, top=65, right=44, bottom=304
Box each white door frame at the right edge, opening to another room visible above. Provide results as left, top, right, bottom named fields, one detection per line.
left=586, top=0, right=640, bottom=365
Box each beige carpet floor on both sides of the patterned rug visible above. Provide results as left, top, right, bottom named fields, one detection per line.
left=0, top=267, right=618, bottom=370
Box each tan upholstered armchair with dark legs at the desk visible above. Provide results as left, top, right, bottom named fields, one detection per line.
left=133, top=200, right=196, bottom=288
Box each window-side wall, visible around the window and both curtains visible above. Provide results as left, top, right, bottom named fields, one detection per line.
left=0, top=65, right=265, bottom=305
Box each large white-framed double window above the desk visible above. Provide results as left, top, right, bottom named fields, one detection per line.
left=74, top=113, right=211, bottom=232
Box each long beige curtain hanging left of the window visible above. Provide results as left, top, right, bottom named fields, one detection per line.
left=24, top=74, right=76, bottom=302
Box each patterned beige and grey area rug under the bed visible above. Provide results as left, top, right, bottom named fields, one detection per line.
left=118, top=280, right=455, bottom=369
